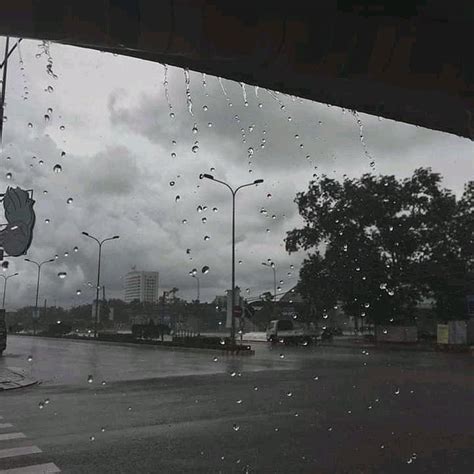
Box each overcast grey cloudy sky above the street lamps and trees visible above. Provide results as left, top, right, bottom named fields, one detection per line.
left=0, top=39, right=474, bottom=309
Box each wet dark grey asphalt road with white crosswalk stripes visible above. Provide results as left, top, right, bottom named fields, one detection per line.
left=0, top=337, right=474, bottom=474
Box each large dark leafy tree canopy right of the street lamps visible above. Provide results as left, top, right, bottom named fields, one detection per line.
left=286, top=168, right=474, bottom=322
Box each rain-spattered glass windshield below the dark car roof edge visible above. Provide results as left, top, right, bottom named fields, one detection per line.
left=0, top=38, right=474, bottom=473
